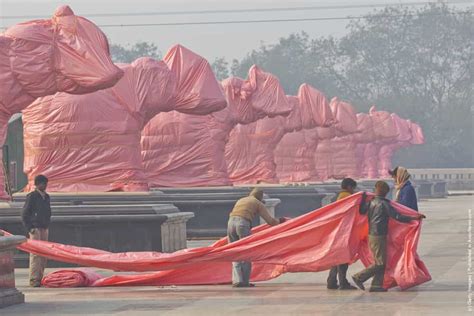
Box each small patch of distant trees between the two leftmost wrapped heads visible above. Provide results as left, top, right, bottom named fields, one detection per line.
left=110, top=42, right=161, bottom=63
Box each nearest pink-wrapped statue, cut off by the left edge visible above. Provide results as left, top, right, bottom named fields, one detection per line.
left=0, top=6, right=122, bottom=199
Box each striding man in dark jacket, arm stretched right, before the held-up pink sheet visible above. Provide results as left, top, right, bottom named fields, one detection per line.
left=352, top=181, right=425, bottom=292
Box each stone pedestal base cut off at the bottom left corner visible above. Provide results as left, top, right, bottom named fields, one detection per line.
left=0, top=236, right=26, bottom=308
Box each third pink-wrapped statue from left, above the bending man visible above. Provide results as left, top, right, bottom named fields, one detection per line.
left=142, top=66, right=291, bottom=187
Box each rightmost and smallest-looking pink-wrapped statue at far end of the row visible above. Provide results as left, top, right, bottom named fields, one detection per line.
left=378, top=113, right=425, bottom=177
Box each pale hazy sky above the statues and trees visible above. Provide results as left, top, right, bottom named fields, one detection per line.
left=0, top=0, right=473, bottom=61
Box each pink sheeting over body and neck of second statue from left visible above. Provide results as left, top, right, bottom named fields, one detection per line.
left=23, top=58, right=180, bottom=192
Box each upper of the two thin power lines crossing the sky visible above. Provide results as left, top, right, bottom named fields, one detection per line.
left=0, top=0, right=472, bottom=20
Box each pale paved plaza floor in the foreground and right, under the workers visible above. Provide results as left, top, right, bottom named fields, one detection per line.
left=0, top=196, right=474, bottom=316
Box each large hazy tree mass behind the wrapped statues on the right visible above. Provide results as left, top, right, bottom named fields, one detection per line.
left=231, top=4, right=474, bottom=167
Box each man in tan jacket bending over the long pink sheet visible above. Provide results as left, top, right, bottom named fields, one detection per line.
left=227, top=188, right=284, bottom=287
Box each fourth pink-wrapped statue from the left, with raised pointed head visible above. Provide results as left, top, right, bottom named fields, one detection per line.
left=226, top=84, right=332, bottom=184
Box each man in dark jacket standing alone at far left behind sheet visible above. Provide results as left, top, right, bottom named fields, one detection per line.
left=22, top=175, right=51, bottom=287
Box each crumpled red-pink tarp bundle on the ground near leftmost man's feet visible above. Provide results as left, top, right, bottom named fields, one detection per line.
left=41, top=269, right=103, bottom=288
